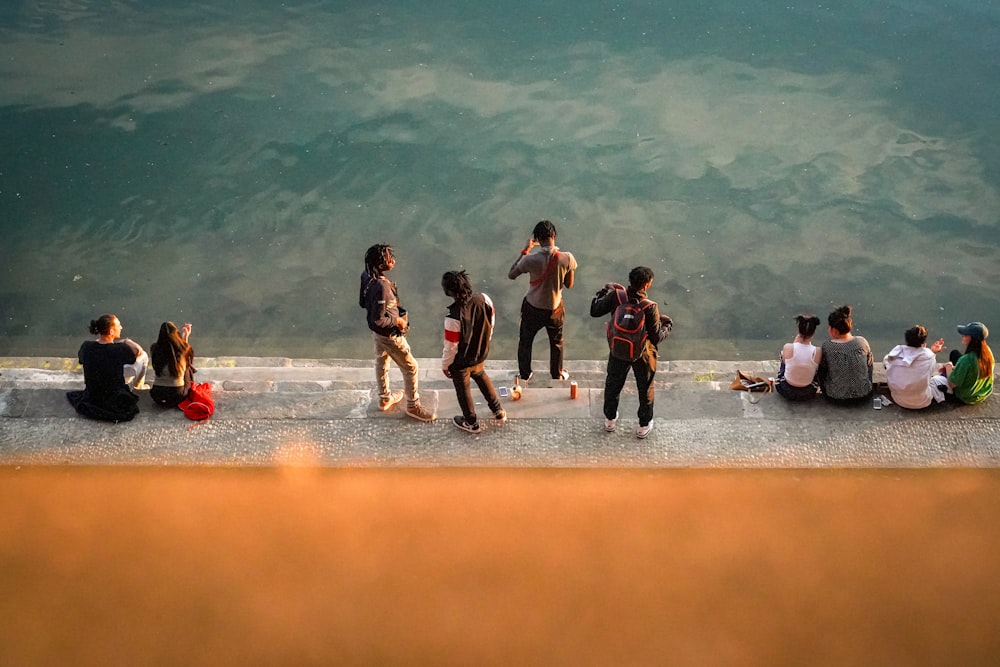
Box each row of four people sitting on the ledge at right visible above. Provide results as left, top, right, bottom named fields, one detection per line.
left=775, top=306, right=994, bottom=410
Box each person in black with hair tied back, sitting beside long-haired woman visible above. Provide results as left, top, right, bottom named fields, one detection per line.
left=66, top=314, right=149, bottom=423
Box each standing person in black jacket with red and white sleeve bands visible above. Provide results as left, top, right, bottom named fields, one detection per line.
left=441, top=271, right=507, bottom=433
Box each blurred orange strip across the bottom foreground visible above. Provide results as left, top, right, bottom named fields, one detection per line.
left=0, top=467, right=1000, bottom=667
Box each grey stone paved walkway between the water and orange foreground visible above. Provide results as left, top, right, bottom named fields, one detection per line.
left=0, top=357, right=1000, bottom=468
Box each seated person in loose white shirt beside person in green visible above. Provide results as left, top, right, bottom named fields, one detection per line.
left=883, top=324, right=944, bottom=410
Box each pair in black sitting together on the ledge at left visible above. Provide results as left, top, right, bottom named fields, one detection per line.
left=66, top=314, right=195, bottom=422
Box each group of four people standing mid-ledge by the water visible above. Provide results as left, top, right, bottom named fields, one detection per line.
left=358, top=220, right=672, bottom=438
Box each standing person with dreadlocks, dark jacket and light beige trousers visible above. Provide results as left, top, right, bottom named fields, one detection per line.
left=359, top=244, right=434, bottom=422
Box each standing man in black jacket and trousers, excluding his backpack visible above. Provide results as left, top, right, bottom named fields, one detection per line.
left=590, top=266, right=673, bottom=438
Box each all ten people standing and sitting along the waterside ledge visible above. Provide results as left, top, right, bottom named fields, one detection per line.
left=67, top=220, right=994, bottom=430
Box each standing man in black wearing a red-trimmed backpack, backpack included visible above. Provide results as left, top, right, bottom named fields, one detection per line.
left=590, top=266, right=673, bottom=438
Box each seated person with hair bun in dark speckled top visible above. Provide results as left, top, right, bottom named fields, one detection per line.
left=818, top=306, right=875, bottom=405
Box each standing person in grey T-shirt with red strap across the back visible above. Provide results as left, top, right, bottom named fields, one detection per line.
left=507, top=220, right=577, bottom=382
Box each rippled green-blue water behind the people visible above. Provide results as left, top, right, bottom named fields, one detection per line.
left=0, top=0, right=1000, bottom=358
